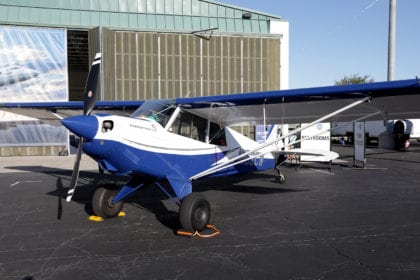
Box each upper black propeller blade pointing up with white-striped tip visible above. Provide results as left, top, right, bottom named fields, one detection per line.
left=83, top=53, right=101, bottom=115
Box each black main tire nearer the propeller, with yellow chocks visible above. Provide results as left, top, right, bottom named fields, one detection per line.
left=92, top=186, right=124, bottom=219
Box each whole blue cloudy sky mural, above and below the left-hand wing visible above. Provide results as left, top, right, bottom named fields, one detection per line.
left=0, top=26, right=68, bottom=149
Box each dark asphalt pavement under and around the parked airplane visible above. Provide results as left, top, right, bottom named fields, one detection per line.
left=0, top=146, right=420, bottom=279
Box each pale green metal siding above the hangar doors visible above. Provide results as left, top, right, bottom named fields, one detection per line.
left=0, top=0, right=280, bottom=34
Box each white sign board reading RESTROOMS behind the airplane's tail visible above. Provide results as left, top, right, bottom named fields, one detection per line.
left=300, top=123, right=331, bottom=162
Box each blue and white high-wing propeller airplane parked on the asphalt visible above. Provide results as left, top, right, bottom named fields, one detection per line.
left=1, top=54, right=420, bottom=232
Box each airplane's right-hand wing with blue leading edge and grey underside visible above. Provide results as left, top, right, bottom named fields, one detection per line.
left=176, top=79, right=420, bottom=126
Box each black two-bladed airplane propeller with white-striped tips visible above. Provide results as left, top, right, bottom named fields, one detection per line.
left=63, top=53, right=101, bottom=202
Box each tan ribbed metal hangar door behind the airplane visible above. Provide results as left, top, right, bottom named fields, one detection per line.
left=102, top=29, right=280, bottom=100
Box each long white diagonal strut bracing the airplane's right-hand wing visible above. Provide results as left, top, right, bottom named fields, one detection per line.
left=190, top=97, right=370, bottom=180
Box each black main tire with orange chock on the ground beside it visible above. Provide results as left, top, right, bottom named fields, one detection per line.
left=179, top=193, right=210, bottom=232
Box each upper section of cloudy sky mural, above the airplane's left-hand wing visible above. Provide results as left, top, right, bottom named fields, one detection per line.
left=0, top=26, right=68, bottom=102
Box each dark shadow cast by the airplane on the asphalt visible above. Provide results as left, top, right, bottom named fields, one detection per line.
left=5, top=166, right=309, bottom=233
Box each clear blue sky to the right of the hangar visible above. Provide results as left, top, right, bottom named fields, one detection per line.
left=219, top=0, right=420, bottom=88
